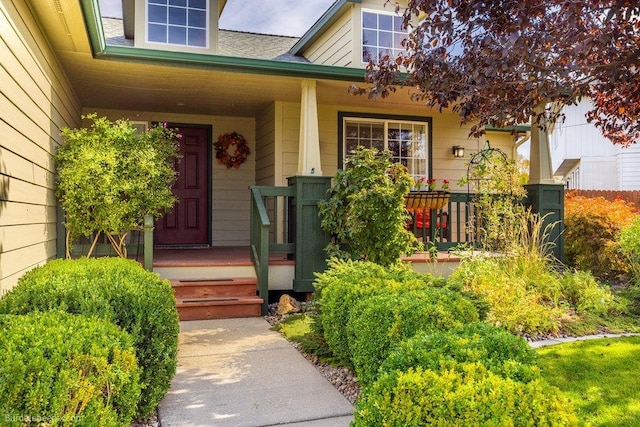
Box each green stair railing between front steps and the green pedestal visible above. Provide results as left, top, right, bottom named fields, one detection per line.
left=249, top=186, right=295, bottom=315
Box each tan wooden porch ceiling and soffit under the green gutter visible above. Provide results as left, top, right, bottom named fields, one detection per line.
left=31, top=1, right=440, bottom=117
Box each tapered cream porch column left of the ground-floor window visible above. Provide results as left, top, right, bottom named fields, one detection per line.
left=297, top=79, right=322, bottom=176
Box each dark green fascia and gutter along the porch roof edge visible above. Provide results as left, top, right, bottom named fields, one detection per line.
left=80, top=0, right=365, bottom=82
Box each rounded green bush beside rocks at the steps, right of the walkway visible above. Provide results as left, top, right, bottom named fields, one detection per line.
left=314, top=259, right=444, bottom=367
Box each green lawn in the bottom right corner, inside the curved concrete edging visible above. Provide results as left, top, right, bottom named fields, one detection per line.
left=538, top=337, right=640, bottom=427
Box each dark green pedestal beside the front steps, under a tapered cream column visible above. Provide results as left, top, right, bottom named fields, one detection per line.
left=288, top=176, right=331, bottom=292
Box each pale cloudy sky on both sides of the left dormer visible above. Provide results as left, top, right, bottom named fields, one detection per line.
left=100, top=0, right=334, bottom=37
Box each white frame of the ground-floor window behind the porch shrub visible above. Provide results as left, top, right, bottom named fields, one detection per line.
left=341, top=115, right=431, bottom=180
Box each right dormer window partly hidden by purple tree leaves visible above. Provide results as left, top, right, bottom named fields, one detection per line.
left=362, top=10, right=408, bottom=62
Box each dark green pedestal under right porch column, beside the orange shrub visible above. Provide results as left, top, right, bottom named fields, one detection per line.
left=525, top=184, right=564, bottom=262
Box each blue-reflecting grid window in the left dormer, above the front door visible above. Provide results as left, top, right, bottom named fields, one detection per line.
left=147, top=0, right=209, bottom=48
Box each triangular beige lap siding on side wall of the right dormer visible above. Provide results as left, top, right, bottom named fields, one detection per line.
left=304, top=6, right=357, bottom=67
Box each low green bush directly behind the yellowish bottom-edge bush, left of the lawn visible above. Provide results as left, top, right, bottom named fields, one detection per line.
left=380, top=322, right=540, bottom=382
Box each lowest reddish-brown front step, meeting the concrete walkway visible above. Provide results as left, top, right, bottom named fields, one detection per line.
left=176, top=296, right=263, bottom=320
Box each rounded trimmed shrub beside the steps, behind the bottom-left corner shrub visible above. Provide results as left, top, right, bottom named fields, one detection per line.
left=0, top=258, right=179, bottom=416
